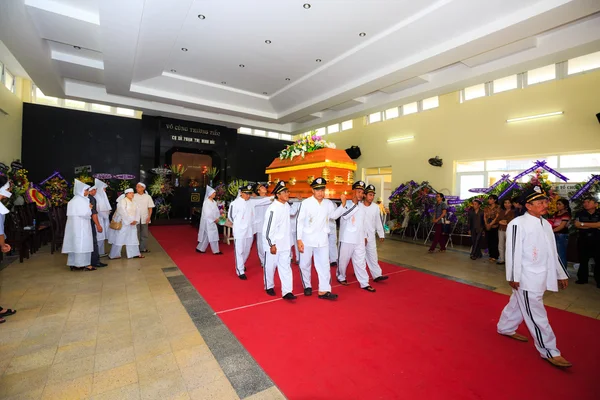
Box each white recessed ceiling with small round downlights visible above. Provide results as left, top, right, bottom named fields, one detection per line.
left=0, top=0, right=600, bottom=132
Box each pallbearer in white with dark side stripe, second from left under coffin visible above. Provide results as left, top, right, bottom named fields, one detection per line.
left=262, top=181, right=296, bottom=300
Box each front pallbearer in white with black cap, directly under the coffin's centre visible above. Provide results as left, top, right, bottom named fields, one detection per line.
left=296, top=177, right=342, bottom=300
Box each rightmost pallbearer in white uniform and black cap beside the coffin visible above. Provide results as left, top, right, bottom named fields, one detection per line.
left=361, top=185, right=388, bottom=282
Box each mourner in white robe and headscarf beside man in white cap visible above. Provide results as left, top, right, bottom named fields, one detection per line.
left=108, top=189, right=143, bottom=259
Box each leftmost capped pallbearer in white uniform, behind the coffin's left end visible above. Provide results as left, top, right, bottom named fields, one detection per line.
left=227, top=185, right=254, bottom=281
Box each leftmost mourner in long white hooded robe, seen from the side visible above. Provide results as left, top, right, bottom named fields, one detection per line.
left=61, top=179, right=95, bottom=269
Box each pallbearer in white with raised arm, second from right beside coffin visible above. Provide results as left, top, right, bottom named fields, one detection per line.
left=337, top=181, right=375, bottom=292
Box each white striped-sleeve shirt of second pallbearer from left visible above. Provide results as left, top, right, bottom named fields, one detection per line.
left=262, top=200, right=292, bottom=251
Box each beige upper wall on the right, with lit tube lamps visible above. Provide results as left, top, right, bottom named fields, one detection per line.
left=327, top=71, right=600, bottom=194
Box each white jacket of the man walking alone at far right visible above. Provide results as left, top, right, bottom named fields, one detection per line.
left=506, top=212, right=568, bottom=293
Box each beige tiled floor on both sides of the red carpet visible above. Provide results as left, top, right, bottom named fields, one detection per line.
left=0, top=233, right=600, bottom=400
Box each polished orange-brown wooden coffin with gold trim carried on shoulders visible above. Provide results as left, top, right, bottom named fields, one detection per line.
left=265, top=149, right=356, bottom=199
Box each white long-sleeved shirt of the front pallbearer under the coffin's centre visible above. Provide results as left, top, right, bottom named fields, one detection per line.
left=296, top=196, right=341, bottom=247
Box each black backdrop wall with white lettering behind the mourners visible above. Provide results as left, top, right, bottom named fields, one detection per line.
left=22, top=103, right=287, bottom=182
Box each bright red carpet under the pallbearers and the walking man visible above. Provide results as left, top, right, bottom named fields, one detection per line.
left=152, top=226, right=600, bottom=400
